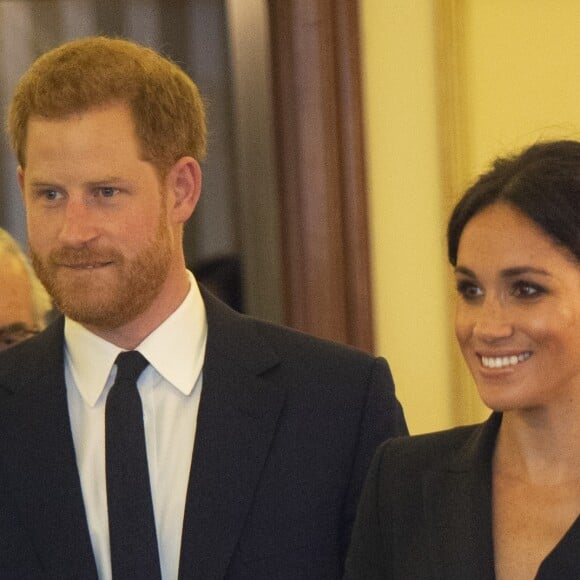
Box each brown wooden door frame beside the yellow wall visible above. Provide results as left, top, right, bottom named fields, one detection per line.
left=268, top=0, right=374, bottom=351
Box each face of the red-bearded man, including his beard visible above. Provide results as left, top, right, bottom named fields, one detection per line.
left=19, top=105, right=177, bottom=329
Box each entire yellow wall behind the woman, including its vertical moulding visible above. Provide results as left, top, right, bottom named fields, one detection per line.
left=360, top=0, right=580, bottom=433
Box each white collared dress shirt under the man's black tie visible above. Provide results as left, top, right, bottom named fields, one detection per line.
left=65, top=274, right=207, bottom=580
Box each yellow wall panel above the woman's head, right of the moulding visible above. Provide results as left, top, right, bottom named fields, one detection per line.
left=462, top=0, right=580, bottom=174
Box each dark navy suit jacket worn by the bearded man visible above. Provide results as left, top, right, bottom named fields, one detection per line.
left=0, top=292, right=407, bottom=580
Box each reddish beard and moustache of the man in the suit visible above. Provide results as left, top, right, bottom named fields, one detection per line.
left=30, top=219, right=172, bottom=330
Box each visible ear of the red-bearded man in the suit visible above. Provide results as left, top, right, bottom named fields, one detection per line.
left=165, top=157, right=201, bottom=224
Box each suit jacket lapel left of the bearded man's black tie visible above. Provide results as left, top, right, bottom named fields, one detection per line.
left=0, top=319, right=97, bottom=579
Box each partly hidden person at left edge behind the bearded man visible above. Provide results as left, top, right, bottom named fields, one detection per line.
left=0, top=228, right=52, bottom=350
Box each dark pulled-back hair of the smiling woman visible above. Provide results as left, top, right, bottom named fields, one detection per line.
left=447, top=141, right=580, bottom=266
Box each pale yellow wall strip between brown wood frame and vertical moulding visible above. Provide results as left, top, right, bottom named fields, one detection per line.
left=361, top=0, right=453, bottom=433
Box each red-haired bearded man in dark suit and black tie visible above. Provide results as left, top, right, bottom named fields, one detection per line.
left=0, top=37, right=407, bottom=580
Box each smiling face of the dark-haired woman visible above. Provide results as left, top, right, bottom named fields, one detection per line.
left=455, top=203, right=580, bottom=411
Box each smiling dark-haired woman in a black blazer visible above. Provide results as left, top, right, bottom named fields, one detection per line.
left=345, top=141, right=580, bottom=580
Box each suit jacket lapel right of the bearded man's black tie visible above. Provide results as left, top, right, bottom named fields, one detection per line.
left=179, top=292, right=286, bottom=580
